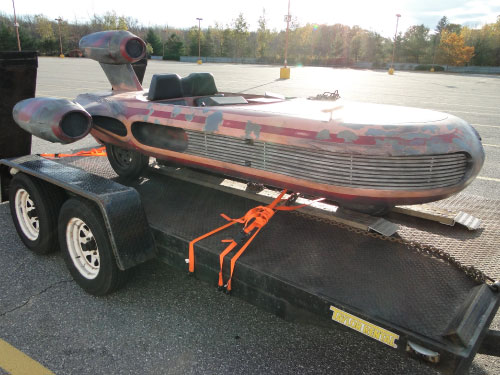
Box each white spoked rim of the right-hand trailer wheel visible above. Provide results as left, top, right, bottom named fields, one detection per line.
left=66, top=217, right=101, bottom=280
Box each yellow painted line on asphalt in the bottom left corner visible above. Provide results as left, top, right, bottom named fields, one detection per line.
left=0, top=339, right=54, bottom=375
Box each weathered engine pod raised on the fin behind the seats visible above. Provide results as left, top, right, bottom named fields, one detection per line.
left=79, top=30, right=146, bottom=64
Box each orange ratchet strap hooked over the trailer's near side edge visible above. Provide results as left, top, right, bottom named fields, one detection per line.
left=189, top=189, right=323, bottom=292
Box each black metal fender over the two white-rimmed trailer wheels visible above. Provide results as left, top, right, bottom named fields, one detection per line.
left=0, top=155, right=157, bottom=271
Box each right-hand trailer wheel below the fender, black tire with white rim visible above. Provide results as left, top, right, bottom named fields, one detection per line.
left=59, top=198, right=130, bottom=296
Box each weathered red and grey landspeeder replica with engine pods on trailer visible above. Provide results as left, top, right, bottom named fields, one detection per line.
left=13, top=31, right=484, bottom=213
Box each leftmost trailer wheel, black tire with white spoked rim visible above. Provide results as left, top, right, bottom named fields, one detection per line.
left=9, top=173, right=64, bottom=254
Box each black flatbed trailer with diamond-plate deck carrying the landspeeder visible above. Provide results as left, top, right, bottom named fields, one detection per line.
left=0, top=155, right=500, bottom=374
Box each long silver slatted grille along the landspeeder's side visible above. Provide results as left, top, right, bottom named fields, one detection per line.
left=185, top=131, right=468, bottom=190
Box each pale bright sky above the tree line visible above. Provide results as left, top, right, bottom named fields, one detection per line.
left=0, top=0, right=500, bottom=36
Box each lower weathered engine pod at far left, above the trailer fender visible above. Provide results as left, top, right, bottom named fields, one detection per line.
left=12, top=98, right=92, bottom=144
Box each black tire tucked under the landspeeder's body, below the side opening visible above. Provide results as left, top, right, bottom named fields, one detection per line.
left=106, top=144, right=149, bottom=180
